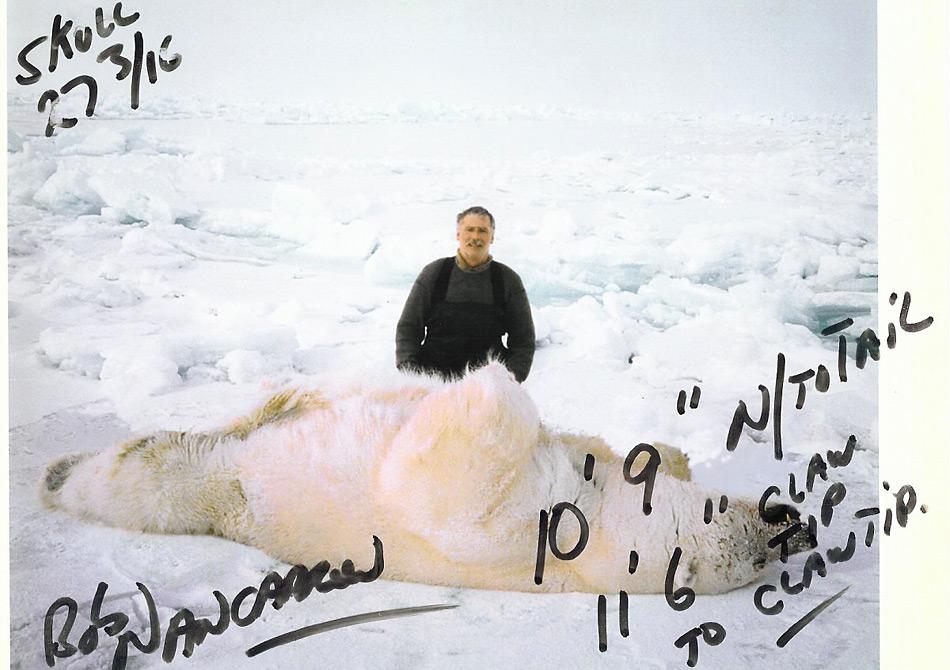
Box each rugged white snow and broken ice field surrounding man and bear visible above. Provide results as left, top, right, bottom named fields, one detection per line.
left=8, top=96, right=878, bottom=669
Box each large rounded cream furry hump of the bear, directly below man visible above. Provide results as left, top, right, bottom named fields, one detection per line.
left=376, top=364, right=540, bottom=528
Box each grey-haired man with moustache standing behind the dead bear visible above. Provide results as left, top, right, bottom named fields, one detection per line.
left=396, top=207, right=534, bottom=382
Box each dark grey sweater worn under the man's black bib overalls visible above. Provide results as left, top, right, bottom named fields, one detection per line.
left=396, top=258, right=534, bottom=382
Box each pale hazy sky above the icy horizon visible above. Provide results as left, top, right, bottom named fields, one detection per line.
left=7, top=0, right=876, bottom=114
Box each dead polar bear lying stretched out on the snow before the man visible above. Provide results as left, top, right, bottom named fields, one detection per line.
left=42, top=363, right=804, bottom=593
